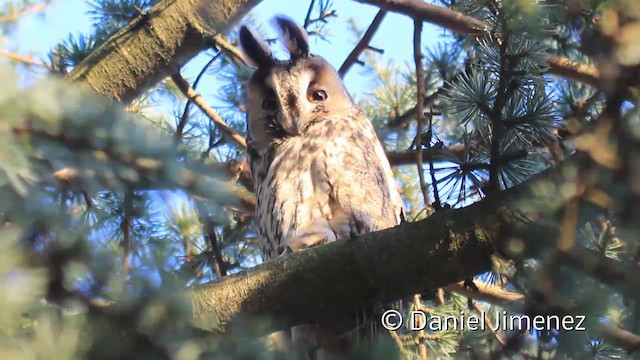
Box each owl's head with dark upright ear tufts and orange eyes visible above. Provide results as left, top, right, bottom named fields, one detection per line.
left=240, top=17, right=354, bottom=150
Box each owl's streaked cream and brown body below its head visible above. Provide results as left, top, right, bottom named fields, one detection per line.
left=249, top=114, right=402, bottom=260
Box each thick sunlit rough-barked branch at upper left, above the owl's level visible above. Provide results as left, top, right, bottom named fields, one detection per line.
left=68, top=0, right=260, bottom=104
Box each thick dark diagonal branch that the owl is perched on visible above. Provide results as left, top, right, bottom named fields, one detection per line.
left=192, top=154, right=598, bottom=334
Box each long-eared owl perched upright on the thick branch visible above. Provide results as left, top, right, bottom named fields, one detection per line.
left=239, top=17, right=403, bottom=260
